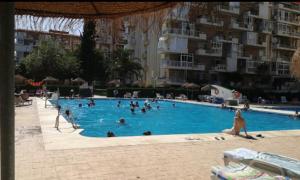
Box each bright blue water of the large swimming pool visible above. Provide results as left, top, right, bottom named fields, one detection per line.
left=54, top=99, right=300, bottom=137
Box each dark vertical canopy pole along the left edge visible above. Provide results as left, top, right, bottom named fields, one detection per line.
left=0, top=2, right=15, bottom=180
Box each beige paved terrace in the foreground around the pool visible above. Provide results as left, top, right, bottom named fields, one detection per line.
left=15, top=98, right=300, bottom=180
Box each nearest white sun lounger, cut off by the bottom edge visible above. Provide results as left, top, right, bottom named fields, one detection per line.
left=210, top=163, right=290, bottom=180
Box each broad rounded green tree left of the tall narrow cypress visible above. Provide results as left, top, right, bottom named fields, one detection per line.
left=19, top=38, right=80, bottom=80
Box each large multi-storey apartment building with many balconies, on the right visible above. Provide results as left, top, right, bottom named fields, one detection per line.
left=126, top=2, right=300, bottom=88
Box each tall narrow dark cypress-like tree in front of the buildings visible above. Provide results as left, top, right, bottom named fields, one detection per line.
left=79, top=20, right=96, bottom=83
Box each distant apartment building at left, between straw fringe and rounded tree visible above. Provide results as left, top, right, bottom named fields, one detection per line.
left=15, top=29, right=80, bottom=64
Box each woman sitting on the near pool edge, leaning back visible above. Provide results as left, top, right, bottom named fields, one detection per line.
left=222, top=109, right=250, bottom=137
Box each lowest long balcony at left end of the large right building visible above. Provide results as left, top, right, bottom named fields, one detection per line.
left=161, top=60, right=205, bottom=71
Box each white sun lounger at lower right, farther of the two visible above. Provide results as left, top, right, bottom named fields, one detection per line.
left=224, top=148, right=300, bottom=179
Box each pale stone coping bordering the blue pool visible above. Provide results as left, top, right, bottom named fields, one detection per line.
left=35, top=98, right=300, bottom=150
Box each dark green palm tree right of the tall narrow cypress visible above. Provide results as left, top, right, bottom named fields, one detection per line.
left=108, top=49, right=143, bottom=84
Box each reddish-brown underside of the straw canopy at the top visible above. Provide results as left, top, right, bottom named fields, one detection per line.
left=15, top=2, right=177, bottom=18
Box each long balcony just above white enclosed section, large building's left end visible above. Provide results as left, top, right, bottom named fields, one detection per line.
left=162, top=28, right=206, bottom=40
